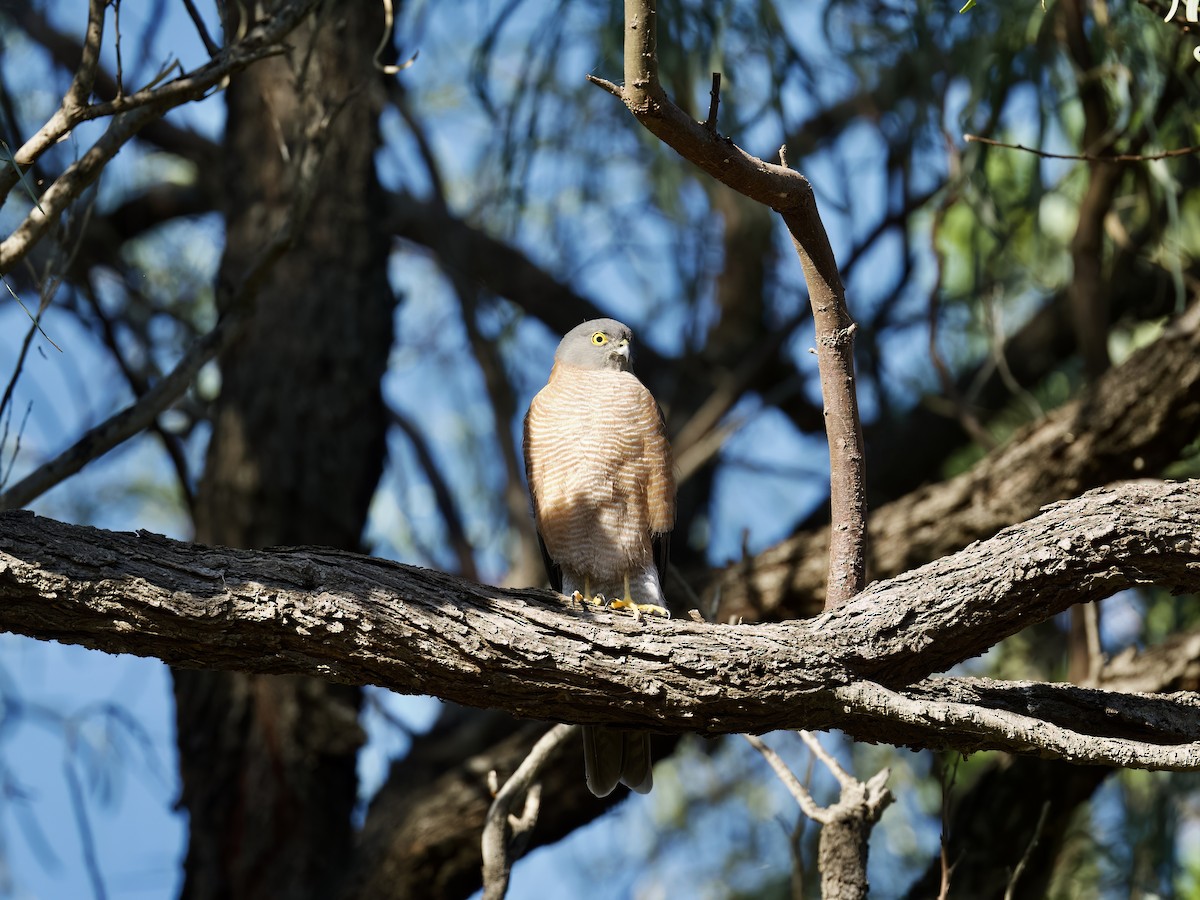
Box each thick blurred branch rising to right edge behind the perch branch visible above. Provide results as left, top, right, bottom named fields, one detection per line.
left=706, top=302, right=1200, bottom=620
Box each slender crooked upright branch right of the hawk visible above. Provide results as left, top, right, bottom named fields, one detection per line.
left=588, top=0, right=866, bottom=608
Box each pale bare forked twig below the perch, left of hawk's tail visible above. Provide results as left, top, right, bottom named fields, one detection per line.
left=484, top=725, right=580, bottom=900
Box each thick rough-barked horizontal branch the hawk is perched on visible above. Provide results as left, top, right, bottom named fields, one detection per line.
left=0, top=481, right=1200, bottom=768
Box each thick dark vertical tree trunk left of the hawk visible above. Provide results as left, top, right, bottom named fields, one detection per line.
left=172, top=4, right=394, bottom=900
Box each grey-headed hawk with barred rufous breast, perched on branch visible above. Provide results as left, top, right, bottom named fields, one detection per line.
left=524, top=319, right=676, bottom=797
